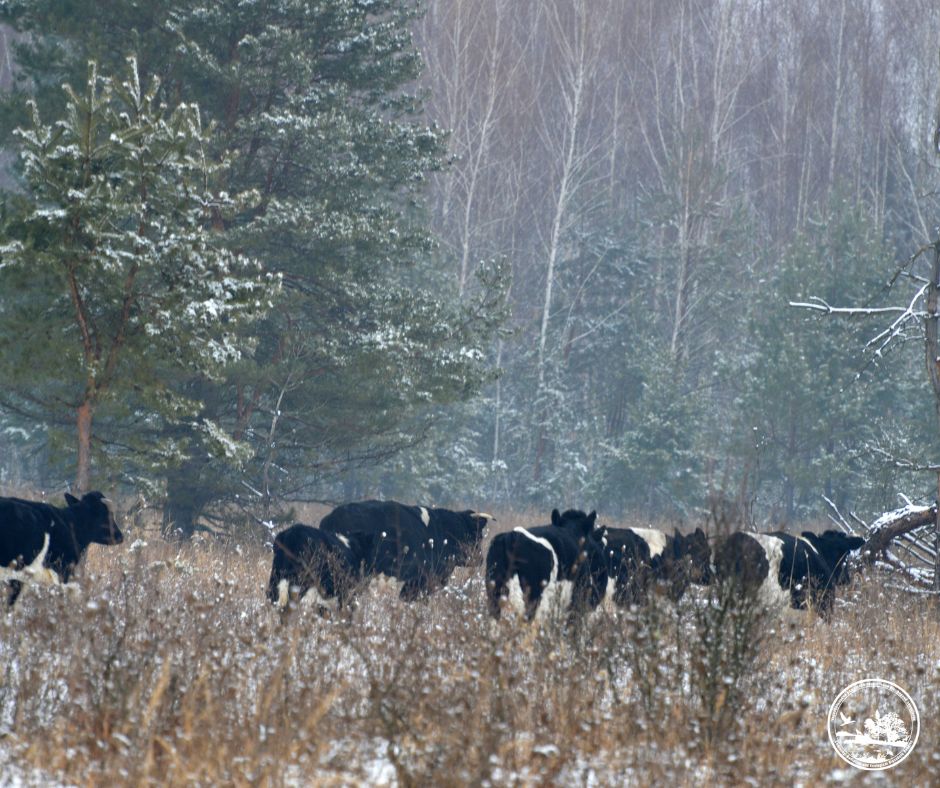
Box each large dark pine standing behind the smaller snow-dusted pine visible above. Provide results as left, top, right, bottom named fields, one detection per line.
left=6, top=0, right=505, bottom=532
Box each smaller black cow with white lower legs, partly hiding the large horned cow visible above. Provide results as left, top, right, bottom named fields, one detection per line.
left=268, top=523, right=375, bottom=612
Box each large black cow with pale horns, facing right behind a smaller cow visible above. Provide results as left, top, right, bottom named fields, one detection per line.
left=320, top=501, right=494, bottom=600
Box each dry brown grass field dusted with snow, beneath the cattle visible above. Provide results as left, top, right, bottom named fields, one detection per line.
left=0, top=502, right=940, bottom=786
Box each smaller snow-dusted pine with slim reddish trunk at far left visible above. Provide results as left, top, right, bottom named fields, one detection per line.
left=0, top=59, right=278, bottom=490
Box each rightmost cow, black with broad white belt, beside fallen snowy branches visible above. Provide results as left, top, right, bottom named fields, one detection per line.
left=715, top=530, right=865, bottom=615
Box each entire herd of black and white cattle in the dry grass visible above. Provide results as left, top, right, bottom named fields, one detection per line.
left=0, top=492, right=864, bottom=620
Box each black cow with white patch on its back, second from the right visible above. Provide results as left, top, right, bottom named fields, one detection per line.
left=592, top=526, right=711, bottom=605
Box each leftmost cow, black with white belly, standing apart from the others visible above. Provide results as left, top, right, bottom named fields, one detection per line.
left=0, top=492, right=124, bottom=606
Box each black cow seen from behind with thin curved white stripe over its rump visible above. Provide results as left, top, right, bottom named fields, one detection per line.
left=486, top=509, right=607, bottom=621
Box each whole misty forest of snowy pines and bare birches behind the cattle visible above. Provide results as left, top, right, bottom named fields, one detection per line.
left=0, top=0, right=940, bottom=533
